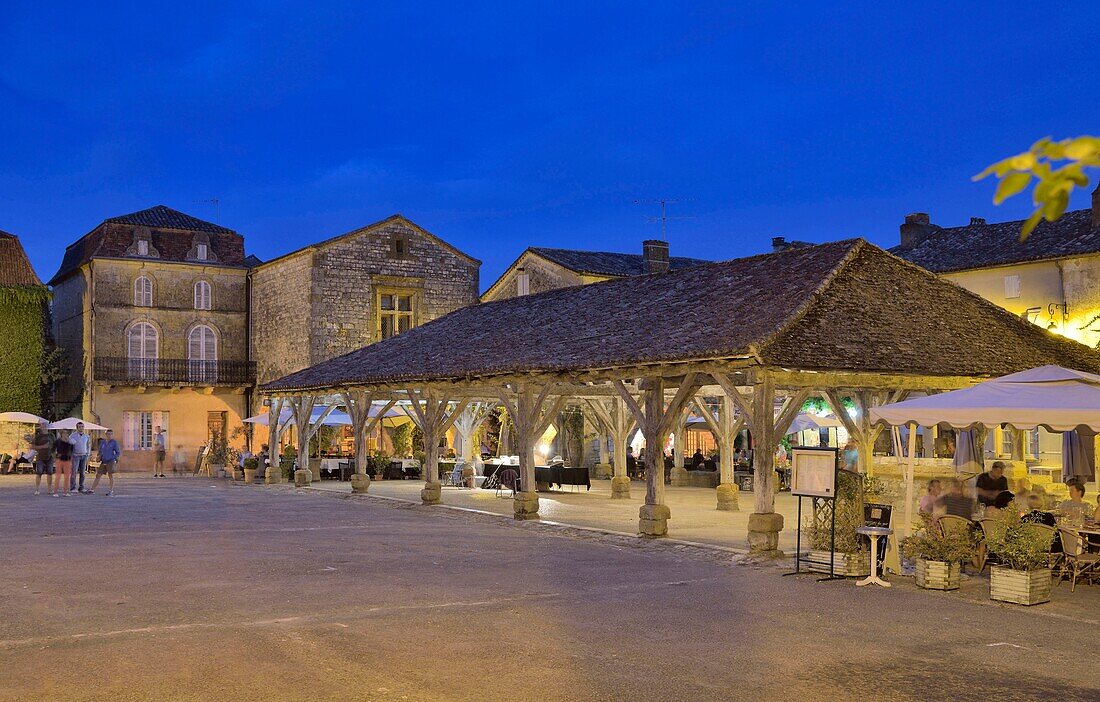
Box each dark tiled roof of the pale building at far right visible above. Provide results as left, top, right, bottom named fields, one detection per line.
left=890, top=209, right=1100, bottom=273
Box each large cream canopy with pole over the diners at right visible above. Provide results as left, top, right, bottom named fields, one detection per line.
left=871, top=365, right=1100, bottom=535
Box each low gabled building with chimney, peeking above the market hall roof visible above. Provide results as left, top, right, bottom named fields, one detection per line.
left=482, top=240, right=708, bottom=301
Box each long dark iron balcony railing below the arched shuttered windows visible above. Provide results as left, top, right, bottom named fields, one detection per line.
left=94, top=357, right=256, bottom=385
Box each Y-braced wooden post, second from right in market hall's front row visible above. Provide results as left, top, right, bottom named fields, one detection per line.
left=612, top=373, right=697, bottom=537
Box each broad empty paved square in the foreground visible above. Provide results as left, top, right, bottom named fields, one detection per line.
left=0, top=475, right=1100, bottom=702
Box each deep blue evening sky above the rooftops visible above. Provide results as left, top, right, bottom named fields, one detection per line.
left=0, top=1, right=1100, bottom=288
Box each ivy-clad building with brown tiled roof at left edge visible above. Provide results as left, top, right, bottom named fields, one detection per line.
left=0, top=231, right=50, bottom=451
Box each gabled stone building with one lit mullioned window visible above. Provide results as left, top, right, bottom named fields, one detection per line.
left=252, top=215, right=481, bottom=383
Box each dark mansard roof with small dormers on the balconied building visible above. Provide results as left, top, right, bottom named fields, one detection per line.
left=50, top=205, right=244, bottom=285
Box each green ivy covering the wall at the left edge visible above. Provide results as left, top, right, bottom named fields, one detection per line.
left=0, top=286, right=50, bottom=415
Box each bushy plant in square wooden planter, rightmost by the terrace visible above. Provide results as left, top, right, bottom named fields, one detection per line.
left=986, top=509, right=1051, bottom=605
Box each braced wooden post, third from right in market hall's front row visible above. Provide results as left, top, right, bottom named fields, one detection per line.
left=499, top=383, right=565, bottom=519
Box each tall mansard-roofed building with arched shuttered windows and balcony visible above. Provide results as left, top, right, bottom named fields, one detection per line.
left=50, top=205, right=254, bottom=470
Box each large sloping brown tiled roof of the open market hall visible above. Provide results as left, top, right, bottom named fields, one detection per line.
left=264, top=240, right=1100, bottom=391
